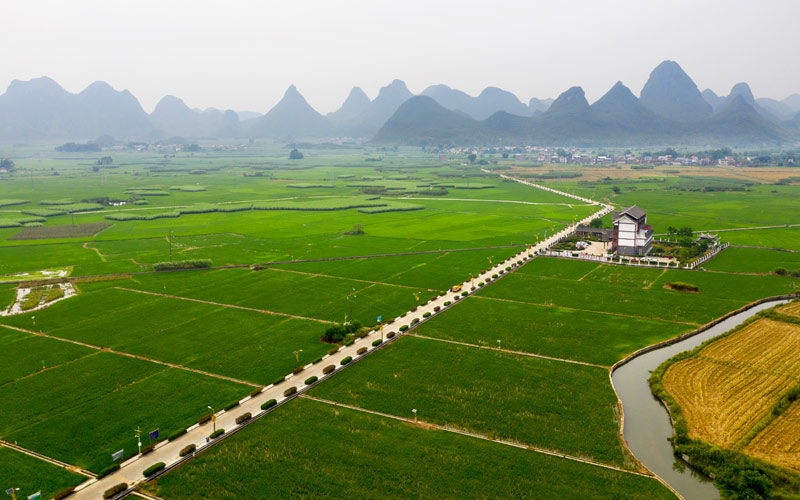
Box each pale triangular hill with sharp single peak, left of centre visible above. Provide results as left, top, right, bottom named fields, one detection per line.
left=246, top=85, right=332, bottom=138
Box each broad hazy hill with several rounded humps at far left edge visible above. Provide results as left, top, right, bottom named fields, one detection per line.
left=0, top=77, right=152, bottom=141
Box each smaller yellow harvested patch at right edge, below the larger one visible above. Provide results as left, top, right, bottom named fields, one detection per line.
left=744, top=401, right=800, bottom=472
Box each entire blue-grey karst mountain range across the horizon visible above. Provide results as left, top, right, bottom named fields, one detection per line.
left=0, top=61, right=800, bottom=146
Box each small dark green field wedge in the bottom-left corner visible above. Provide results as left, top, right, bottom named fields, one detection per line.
left=0, top=446, right=86, bottom=499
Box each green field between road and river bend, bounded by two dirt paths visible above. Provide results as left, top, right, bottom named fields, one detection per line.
left=309, top=337, right=631, bottom=467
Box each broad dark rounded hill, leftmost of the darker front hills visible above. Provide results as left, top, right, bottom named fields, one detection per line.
left=373, top=96, right=482, bottom=145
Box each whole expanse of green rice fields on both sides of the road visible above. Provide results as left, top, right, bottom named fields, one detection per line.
left=0, top=148, right=800, bottom=500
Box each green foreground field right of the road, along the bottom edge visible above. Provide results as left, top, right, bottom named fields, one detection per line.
left=147, top=399, right=674, bottom=500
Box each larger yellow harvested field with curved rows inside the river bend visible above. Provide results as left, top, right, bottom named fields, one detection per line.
left=663, top=319, right=800, bottom=448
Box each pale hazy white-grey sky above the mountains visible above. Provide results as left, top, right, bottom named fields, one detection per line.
left=0, top=0, right=800, bottom=112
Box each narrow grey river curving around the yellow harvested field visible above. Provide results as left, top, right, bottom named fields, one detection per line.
left=611, top=299, right=790, bottom=500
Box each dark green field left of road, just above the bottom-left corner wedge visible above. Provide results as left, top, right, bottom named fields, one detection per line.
left=0, top=346, right=249, bottom=472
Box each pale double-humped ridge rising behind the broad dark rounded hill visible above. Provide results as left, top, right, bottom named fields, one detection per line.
left=422, top=85, right=531, bottom=120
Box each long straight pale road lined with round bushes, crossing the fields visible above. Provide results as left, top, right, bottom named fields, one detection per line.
left=73, top=176, right=614, bottom=500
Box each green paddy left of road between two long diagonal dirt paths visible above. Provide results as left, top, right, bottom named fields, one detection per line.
left=0, top=281, right=330, bottom=385
